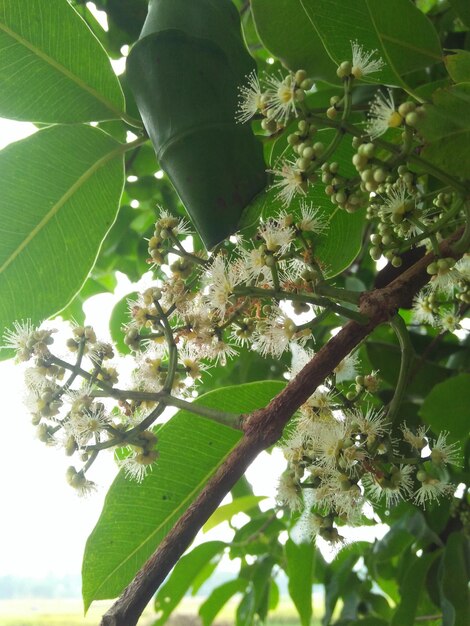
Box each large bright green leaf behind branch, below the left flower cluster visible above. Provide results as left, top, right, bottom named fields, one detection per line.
left=83, top=381, right=284, bottom=609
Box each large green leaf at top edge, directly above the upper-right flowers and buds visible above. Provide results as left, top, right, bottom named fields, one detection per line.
left=253, top=0, right=442, bottom=92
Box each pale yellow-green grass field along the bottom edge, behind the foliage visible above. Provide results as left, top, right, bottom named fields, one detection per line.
left=0, top=598, right=317, bottom=626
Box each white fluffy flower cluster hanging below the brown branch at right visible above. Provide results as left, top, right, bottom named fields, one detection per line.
left=278, top=348, right=460, bottom=541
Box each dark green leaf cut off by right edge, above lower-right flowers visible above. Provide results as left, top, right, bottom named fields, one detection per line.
left=419, top=374, right=470, bottom=442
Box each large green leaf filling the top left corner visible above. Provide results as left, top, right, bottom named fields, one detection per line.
left=0, top=0, right=124, bottom=124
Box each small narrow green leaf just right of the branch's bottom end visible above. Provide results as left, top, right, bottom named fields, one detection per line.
left=154, top=541, right=225, bottom=626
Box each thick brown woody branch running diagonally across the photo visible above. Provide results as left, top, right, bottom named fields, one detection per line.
left=101, top=230, right=462, bottom=626
